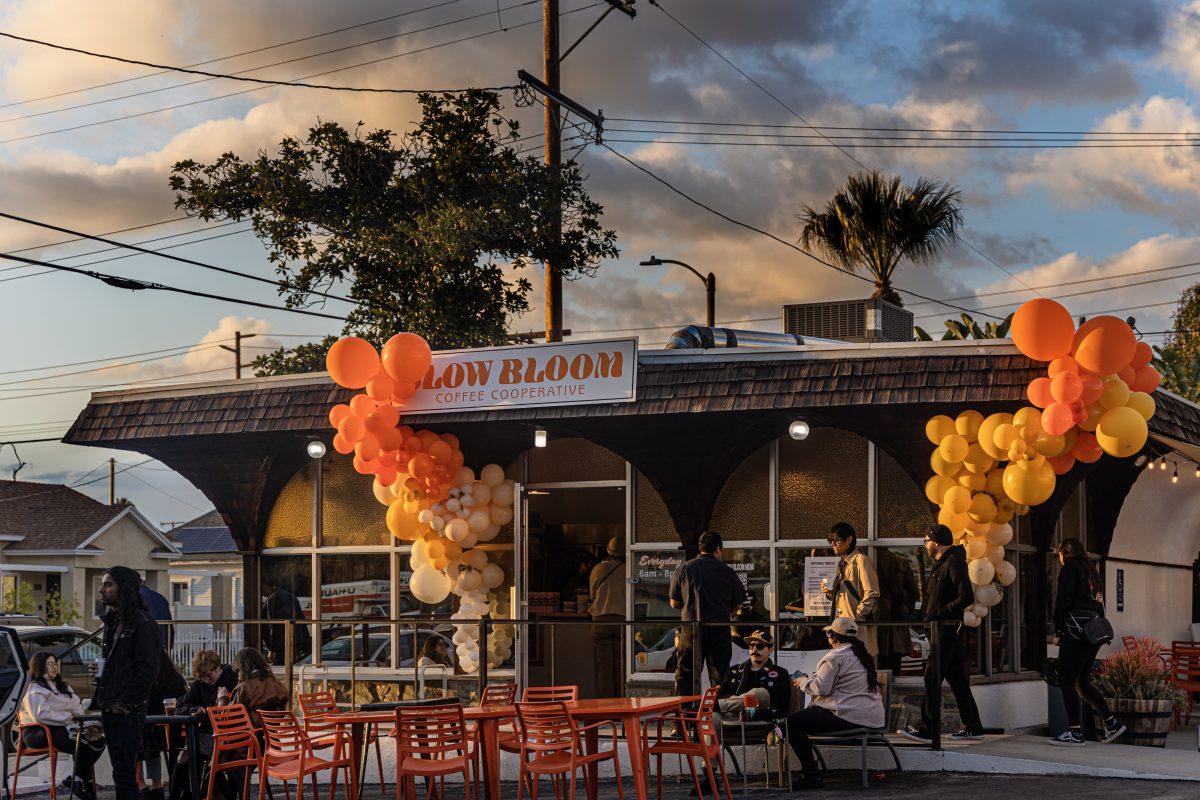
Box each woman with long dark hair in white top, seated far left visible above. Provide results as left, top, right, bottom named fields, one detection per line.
left=19, top=651, right=104, bottom=800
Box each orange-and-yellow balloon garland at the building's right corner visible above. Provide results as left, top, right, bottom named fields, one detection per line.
left=925, top=297, right=1162, bottom=627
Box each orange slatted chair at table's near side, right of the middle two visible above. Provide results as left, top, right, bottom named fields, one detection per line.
left=517, top=702, right=625, bottom=800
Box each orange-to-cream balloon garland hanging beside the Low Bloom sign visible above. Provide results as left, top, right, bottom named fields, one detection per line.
left=325, top=333, right=515, bottom=673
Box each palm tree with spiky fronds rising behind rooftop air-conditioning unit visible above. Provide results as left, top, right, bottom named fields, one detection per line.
left=799, top=172, right=962, bottom=306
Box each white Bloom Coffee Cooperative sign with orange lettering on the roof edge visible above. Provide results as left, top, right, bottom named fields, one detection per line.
left=402, top=339, right=637, bottom=414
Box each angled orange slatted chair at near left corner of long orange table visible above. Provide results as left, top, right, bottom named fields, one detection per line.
left=258, top=711, right=350, bottom=800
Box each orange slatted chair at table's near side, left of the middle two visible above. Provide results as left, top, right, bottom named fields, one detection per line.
left=395, top=702, right=476, bottom=800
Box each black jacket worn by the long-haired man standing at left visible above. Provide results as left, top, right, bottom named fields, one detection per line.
left=91, top=608, right=162, bottom=714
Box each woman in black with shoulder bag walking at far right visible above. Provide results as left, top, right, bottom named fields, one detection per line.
left=1050, top=539, right=1126, bottom=747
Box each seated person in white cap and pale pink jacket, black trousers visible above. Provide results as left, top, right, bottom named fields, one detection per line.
left=787, top=616, right=886, bottom=790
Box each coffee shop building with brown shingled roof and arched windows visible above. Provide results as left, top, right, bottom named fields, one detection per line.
left=65, top=331, right=1200, bottom=729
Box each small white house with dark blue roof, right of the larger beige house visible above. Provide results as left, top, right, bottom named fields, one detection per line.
left=167, top=511, right=242, bottom=620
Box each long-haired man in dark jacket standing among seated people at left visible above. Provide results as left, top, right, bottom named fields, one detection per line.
left=91, top=566, right=162, bottom=800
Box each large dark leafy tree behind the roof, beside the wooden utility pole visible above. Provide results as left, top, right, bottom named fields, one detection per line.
left=170, top=90, right=617, bottom=373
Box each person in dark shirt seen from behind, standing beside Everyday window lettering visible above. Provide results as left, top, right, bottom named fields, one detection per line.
left=671, top=530, right=746, bottom=694
